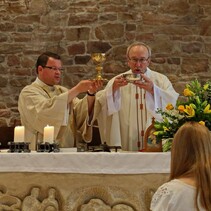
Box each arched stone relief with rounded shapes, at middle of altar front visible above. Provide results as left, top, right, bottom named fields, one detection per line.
left=65, top=186, right=140, bottom=211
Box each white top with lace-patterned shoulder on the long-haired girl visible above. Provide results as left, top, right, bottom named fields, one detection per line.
left=150, top=179, right=205, bottom=211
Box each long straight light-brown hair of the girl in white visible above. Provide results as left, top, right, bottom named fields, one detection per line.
left=170, top=122, right=211, bottom=210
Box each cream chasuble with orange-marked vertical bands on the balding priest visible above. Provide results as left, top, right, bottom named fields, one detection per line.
left=98, top=68, right=178, bottom=151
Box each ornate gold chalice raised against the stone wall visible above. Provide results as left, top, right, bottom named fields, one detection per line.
left=91, top=53, right=106, bottom=80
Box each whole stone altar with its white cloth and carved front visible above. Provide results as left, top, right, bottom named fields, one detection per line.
left=0, top=149, right=170, bottom=211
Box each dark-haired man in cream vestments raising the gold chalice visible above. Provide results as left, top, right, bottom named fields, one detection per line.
left=18, top=52, right=102, bottom=150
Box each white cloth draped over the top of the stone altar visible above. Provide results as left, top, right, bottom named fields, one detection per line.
left=0, top=148, right=170, bottom=174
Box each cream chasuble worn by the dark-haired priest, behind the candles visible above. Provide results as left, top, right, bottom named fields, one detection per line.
left=18, top=78, right=92, bottom=150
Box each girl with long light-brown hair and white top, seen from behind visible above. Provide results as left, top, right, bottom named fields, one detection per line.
left=150, top=122, right=211, bottom=211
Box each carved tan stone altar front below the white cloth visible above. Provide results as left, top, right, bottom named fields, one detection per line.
left=0, top=172, right=168, bottom=211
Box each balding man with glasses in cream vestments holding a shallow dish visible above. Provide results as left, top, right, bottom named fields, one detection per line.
left=96, top=43, right=178, bottom=151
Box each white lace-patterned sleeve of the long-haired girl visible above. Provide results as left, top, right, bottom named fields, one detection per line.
left=150, top=184, right=172, bottom=211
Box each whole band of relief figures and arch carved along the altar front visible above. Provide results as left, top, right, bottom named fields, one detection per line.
left=0, top=183, right=155, bottom=211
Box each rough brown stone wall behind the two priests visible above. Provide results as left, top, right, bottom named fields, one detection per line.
left=0, top=0, right=211, bottom=126
